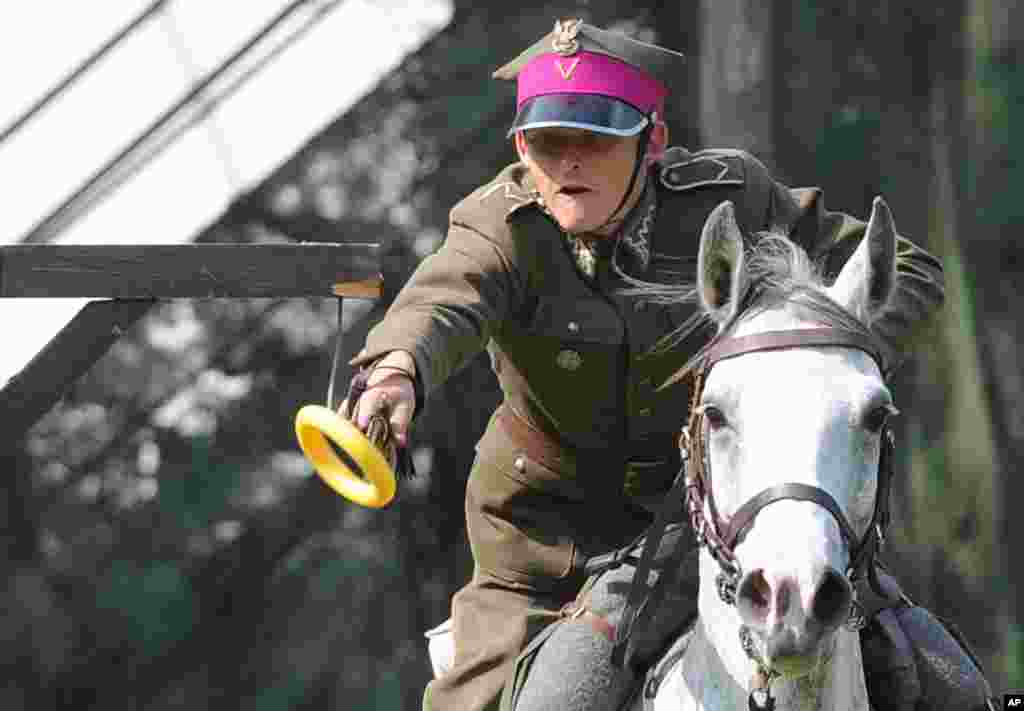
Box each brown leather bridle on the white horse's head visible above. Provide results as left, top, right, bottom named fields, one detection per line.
left=679, top=328, right=894, bottom=618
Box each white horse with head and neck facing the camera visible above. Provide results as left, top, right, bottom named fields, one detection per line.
left=647, top=199, right=896, bottom=711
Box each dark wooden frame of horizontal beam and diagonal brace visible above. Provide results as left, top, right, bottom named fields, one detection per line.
left=0, top=243, right=383, bottom=442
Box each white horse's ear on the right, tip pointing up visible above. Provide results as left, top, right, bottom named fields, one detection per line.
left=829, top=197, right=896, bottom=323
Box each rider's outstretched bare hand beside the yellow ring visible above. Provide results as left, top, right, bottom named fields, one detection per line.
left=339, top=350, right=416, bottom=447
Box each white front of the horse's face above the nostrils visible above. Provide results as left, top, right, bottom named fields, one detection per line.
left=703, top=313, right=888, bottom=610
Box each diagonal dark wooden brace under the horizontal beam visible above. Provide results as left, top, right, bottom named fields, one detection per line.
left=0, top=299, right=156, bottom=440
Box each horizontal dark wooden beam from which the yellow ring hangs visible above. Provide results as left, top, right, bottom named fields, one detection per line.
left=0, top=242, right=382, bottom=299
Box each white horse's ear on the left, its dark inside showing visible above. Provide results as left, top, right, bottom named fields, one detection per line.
left=697, top=201, right=746, bottom=326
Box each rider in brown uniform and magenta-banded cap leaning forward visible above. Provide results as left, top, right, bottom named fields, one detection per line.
left=351, top=20, right=983, bottom=711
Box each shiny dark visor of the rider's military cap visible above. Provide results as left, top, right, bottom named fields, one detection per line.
left=509, top=94, right=648, bottom=136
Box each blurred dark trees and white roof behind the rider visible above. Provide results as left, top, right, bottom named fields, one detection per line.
left=0, top=0, right=1024, bottom=711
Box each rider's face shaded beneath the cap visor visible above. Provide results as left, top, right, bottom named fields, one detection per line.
left=515, top=127, right=639, bottom=233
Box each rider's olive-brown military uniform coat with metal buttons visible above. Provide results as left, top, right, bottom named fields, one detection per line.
left=352, top=149, right=943, bottom=710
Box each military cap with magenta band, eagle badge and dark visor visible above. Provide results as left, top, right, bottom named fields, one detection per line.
left=494, top=19, right=684, bottom=136
